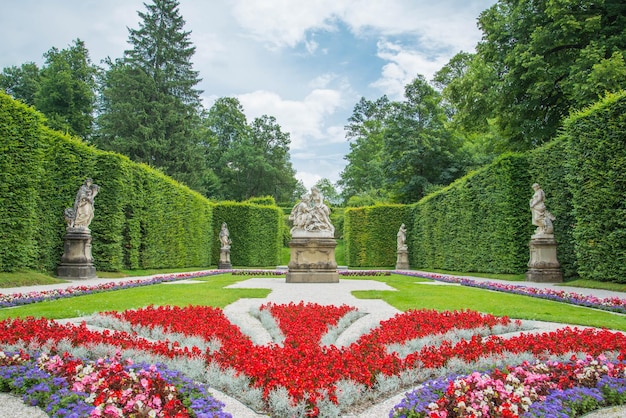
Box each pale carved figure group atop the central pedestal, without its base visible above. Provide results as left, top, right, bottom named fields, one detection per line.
left=289, top=187, right=335, bottom=236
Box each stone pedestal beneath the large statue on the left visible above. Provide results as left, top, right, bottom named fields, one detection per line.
left=57, top=228, right=96, bottom=279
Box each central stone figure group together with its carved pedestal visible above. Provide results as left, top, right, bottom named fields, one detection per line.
left=287, top=187, right=339, bottom=283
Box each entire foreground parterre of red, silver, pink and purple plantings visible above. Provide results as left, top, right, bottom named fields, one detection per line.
left=0, top=275, right=626, bottom=418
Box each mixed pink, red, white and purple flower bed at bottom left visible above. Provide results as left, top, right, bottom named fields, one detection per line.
left=0, top=351, right=231, bottom=418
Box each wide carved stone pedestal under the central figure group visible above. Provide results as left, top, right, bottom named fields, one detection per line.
left=286, top=237, right=339, bottom=283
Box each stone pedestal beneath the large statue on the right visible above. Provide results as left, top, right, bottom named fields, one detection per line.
left=526, top=235, right=563, bottom=283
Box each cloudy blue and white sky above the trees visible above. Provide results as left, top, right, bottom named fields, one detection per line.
left=0, top=0, right=496, bottom=189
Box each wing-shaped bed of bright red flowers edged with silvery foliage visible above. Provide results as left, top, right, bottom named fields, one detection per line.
left=0, top=303, right=626, bottom=416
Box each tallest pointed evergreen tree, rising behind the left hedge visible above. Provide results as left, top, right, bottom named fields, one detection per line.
left=96, top=0, right=214, bottom=194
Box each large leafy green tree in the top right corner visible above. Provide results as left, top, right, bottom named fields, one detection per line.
left=470, top=0, right=626, bottom=150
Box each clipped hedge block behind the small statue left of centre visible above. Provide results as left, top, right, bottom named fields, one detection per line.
left=212, top=202, right=284, bottom=267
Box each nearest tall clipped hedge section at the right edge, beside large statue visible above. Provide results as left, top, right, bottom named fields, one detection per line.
left=565, top=92, right=626, bottom=283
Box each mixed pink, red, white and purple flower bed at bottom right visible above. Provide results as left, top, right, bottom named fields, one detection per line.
left=390, top=356, right=626, bottom=418
